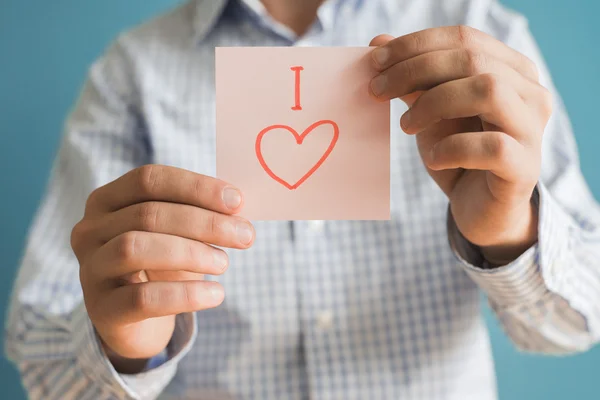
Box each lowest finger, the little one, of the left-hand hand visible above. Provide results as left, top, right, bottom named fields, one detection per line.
left=101, top=281, right=225, bottom=323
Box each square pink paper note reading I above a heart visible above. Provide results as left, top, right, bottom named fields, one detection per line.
left=216, top=47, right=390, bottom=220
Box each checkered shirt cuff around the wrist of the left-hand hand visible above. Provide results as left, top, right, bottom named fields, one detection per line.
left=71, top=304, right=197, bottom=399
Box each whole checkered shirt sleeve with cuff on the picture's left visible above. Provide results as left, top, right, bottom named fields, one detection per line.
left=5, top=37, right=196, bottom=400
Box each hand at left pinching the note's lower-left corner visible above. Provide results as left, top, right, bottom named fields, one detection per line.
left=71, top=165, right=255, bottom=363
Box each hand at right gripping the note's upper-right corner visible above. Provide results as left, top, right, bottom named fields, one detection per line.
left=370, top=26, right=552, bottom=265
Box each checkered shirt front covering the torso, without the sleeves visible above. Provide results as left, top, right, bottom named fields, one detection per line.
left=116, top=0, right=516, bottom=400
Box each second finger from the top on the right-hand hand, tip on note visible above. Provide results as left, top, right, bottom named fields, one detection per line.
left=370, top=49, right=537, bottom=100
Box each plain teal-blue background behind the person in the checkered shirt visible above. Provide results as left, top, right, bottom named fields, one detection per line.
left=0, top=0, right=600, bottom=400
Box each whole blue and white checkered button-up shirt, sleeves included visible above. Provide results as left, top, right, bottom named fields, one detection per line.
left=6, top=0, right=600, bottom=400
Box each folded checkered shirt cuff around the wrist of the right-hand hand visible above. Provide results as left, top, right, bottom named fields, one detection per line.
left=448, top=183, right=573, bottom=308
